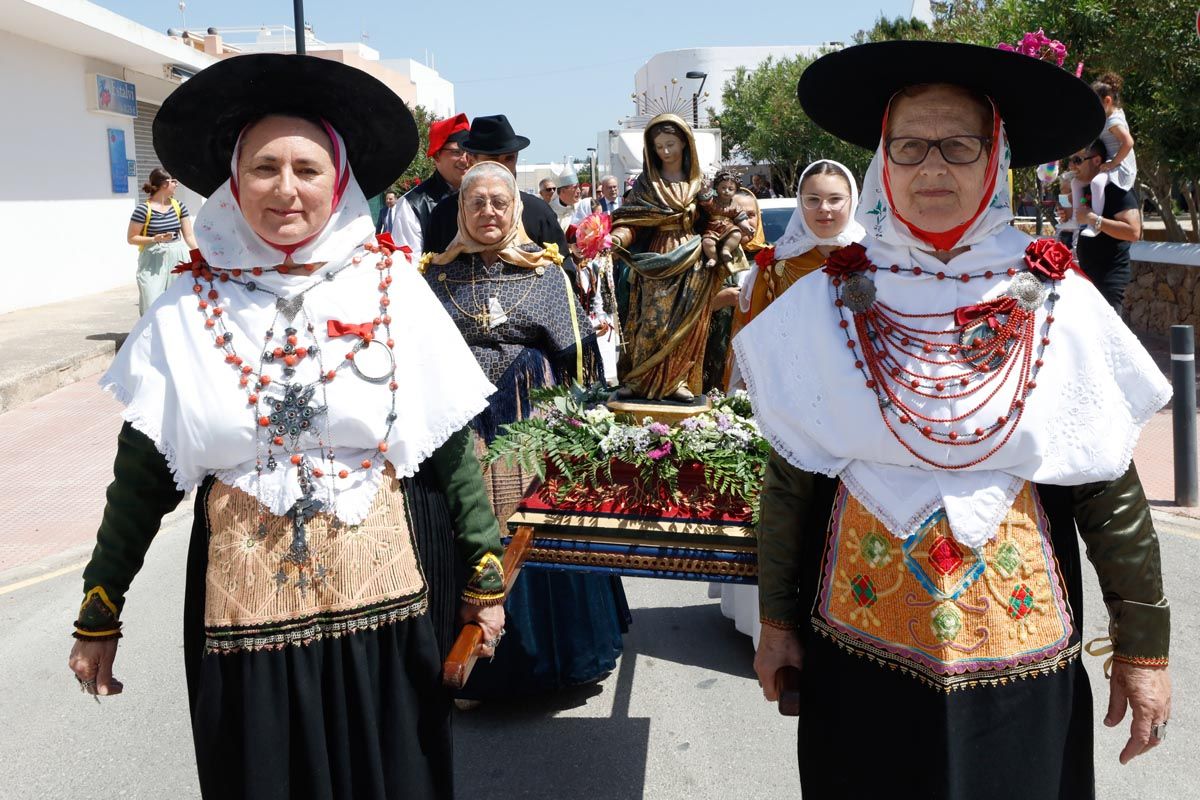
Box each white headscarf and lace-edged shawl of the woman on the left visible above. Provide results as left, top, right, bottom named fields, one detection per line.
left=101, top=115, right=496, bottom=524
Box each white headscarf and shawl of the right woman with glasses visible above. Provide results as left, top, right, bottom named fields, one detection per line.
left=733, top=101, right=1171, bottom=547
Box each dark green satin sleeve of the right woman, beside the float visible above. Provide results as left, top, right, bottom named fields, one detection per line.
left=758, top=450, right=817, bottom=630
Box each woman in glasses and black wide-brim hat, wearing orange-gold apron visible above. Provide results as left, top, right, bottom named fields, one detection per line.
left=733, top=42, right=1170, bottom=800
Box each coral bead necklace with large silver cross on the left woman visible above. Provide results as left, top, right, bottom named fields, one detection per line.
left=178, top=237, right=398, bottom=575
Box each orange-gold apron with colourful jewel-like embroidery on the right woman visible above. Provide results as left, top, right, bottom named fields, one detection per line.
left=812, top=483, right=1080, bottom=691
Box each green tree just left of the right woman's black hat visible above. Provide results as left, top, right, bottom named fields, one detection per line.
left=709, top=56, right=871, bottom=191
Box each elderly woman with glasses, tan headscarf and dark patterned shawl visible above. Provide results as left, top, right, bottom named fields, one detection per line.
left=425, top=162, right=629, bottom=699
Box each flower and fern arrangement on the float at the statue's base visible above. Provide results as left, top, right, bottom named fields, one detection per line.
left=487, top=385, right=770, bottom=522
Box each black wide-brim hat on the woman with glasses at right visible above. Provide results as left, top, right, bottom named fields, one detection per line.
left=797, top=41, right=1104, bottom=167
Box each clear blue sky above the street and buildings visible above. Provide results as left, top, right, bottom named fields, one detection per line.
left=97, top=0, right=912, bottom=162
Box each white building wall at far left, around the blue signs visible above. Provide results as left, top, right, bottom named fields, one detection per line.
left=0, top=31, right=138, bottom=313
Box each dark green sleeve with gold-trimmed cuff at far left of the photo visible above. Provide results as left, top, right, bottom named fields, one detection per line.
left=76, top=422, right=184, bottom=639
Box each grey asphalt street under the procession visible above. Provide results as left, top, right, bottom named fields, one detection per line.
left=0, top=510, right=1200, bottom=800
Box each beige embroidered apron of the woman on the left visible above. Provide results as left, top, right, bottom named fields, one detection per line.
left=204, top=465, right=427, bottom=652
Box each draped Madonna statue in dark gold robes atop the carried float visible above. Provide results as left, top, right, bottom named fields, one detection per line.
left=612, top=114, right=745, bottom=402
